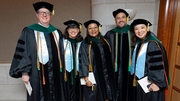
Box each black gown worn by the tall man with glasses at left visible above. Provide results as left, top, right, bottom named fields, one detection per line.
left=9, top=25, right=65, bottom=101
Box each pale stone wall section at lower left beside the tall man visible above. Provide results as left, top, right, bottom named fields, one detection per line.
left=0, top=64, right=26, bottom=101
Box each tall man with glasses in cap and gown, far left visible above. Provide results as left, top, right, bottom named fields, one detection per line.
left=9, top=2, right=66, bottom=101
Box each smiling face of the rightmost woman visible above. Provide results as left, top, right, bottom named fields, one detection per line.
left=134, top=24, right=147, bottom=39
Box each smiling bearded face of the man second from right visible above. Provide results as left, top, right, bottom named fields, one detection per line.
left=115, top=13, right=127, bottom=28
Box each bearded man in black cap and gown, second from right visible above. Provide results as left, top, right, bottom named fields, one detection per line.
left=105, top=9, right=131, bottom=101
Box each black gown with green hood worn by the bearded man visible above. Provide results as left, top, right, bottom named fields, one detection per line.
left=105, top=25, right=131, bottom=101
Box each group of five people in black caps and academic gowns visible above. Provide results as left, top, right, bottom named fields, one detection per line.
left=9, top=1, right=169, bottom=101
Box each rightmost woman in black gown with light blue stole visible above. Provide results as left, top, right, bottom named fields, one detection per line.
left=129, top=19, right=168, bottom=101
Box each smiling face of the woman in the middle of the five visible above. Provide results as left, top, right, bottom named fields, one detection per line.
left=87, top=23, right=99, bottom=37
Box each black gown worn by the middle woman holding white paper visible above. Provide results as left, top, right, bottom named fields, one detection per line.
left=79, top=39, right=112, bottom=101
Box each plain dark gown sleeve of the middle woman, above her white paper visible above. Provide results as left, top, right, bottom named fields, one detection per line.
left=79, top=42, right=89, bottom=77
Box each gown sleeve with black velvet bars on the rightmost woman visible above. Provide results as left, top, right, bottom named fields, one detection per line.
left=147, top=41, right=168, bottom=88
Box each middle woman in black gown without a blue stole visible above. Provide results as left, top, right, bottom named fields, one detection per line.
left=79, top=20, right=113, bottom=101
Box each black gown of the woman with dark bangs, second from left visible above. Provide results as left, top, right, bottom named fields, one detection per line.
left=65, top=39, right=83, bottom=101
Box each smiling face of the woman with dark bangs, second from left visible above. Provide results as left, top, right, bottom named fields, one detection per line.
left=67, top=27, right=79, bottom=39
